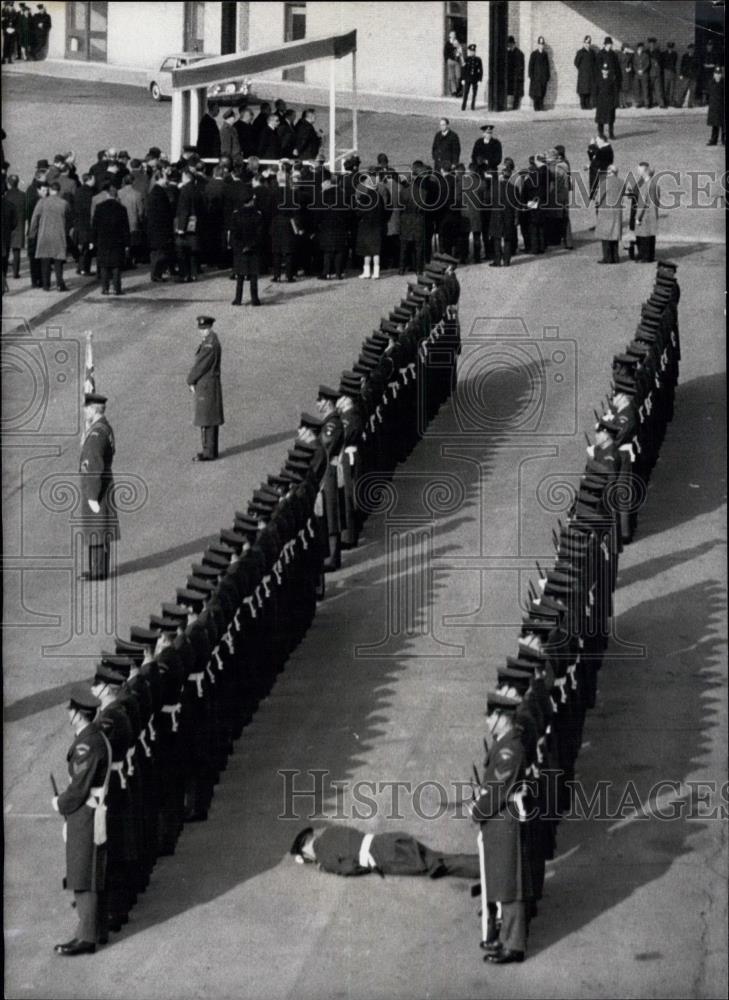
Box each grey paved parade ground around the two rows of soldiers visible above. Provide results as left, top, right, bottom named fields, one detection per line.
left=3, top=68, right=726, bottom=1000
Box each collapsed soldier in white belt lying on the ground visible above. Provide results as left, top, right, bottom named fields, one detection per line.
left=289, top=825, right=479, bottom=879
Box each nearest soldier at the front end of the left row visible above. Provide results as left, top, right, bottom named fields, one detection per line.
left=53, top=684, right=111, bottom=956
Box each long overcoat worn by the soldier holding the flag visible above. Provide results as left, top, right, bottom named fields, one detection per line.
left=79, top=414, right=119, bottom=545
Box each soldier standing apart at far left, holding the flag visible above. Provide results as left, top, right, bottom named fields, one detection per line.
left=79, top=392, right=119, bottom=580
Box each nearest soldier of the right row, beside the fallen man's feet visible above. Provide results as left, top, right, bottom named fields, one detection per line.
left=471, top=694, right=534, bottom=965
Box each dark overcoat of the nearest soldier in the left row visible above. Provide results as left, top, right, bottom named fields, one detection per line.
left=58, top=722, right=111, bottom=892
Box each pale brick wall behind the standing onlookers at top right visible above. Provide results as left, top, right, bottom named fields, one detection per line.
left=520, top=0, right=695, bottom=108
